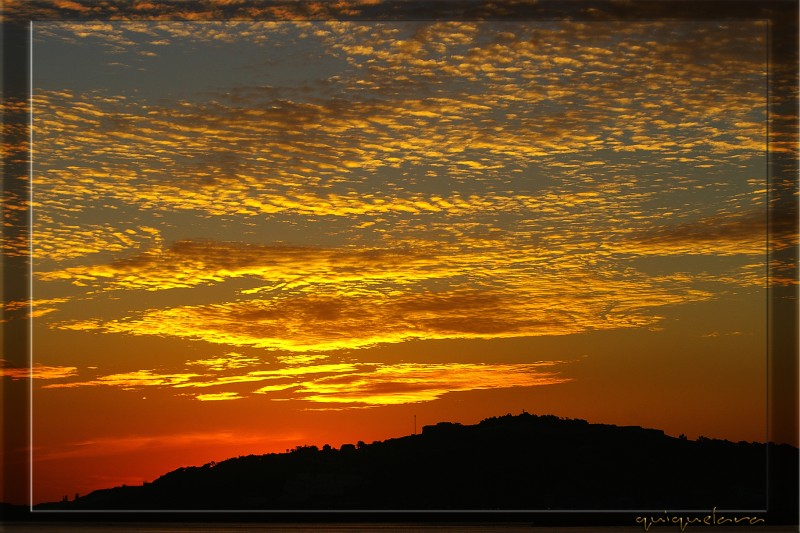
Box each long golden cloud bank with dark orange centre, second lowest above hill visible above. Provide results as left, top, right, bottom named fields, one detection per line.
left=51, top=272, right=710, bottom=352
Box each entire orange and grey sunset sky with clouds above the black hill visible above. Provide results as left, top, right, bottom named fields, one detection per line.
left=2, top=1, right=796, bottom=508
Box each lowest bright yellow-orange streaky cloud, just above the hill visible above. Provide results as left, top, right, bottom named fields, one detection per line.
left=44, top=361, right=570, bottom=406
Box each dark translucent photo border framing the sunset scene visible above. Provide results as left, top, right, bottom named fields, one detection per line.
left=0, top=0, right=800, bottom=531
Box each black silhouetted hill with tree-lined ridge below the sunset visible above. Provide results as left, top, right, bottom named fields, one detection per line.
left=37, top=413, right=798, bottom=510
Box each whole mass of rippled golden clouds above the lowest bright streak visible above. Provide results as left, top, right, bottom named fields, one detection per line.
left=25, top=20, right=780, bottom=368
